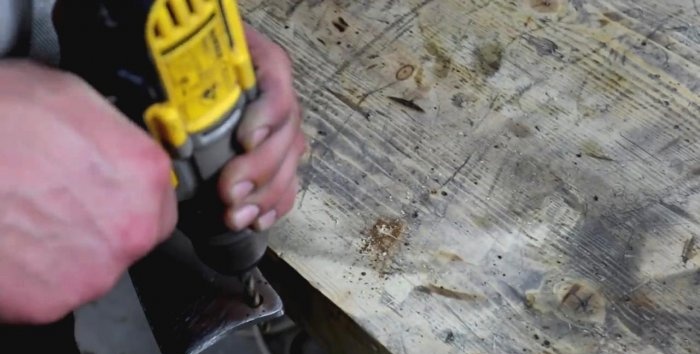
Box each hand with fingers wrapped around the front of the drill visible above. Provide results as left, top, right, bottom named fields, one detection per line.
left=219, top=26, right=306, bottom=231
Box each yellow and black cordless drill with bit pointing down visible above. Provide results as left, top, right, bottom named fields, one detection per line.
left=54, top=0, right=267, bottom=305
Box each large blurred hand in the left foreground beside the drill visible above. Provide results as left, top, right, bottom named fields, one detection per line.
left=0, top=61, right=177, bottom=324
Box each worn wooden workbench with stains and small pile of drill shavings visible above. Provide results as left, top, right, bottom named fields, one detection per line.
left=241, top=0, right=700, bottom=354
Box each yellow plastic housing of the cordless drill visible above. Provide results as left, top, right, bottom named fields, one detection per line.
left=144, top=0, right=255, bottom=188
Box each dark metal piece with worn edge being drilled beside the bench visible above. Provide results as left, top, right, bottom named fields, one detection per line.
left=129, top=234, right=284, bottom=354
